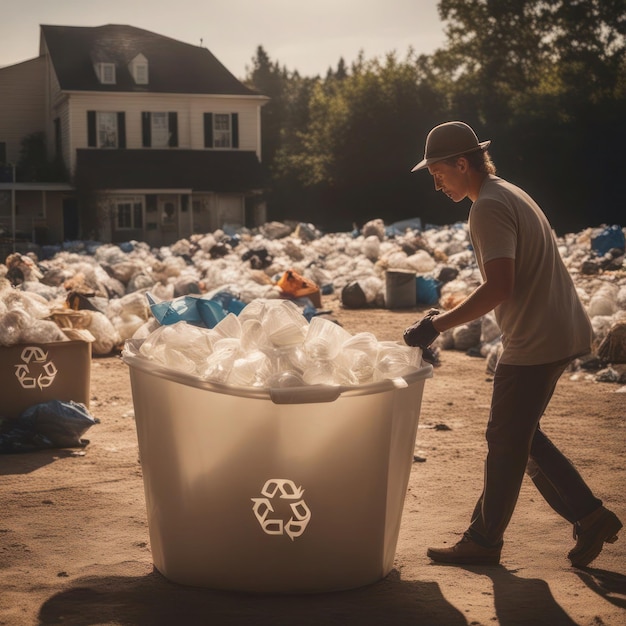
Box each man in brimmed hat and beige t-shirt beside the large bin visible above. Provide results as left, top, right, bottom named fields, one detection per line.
left=404, top=122, right=622, bottom=567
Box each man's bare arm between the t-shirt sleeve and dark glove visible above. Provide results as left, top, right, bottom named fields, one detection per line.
left=433, top=257, right=515, bottom=333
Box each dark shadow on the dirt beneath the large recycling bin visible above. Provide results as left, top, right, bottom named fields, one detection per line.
left=39, top=570, right=467, bottom=626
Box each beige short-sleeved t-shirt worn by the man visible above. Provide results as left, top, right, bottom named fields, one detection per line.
left=468, top=176, right=593, bottom=365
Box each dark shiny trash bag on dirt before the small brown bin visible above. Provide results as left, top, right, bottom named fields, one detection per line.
left=0, top=400, right=100, bottom=453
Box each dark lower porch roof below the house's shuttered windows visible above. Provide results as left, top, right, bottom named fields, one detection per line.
left=76, top=149, right=263, bottom=193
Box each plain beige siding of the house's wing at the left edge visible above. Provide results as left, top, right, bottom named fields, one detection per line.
left=0, top=57, right=46, bottom=163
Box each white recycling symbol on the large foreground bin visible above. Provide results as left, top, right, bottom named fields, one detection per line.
left=251, top=478, right=311, bottom=541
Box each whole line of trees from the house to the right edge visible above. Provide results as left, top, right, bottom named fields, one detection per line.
left=244, top=0, right=626, bottom=233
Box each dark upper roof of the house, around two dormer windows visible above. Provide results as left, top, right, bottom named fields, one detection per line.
left=40, top=24, right=259, bottom=96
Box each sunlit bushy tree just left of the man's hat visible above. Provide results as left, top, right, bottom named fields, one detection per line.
left=275, top=51, right=450, bottom=227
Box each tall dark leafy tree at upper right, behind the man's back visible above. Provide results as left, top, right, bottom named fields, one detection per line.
left=431, top=0, right=626, bottom=229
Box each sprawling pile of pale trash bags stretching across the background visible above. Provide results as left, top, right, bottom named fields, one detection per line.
left=0, top=219, right=626, bottom=382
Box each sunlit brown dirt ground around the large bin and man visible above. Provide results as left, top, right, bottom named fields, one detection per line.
left=0, top=297, right=626, bottom=626
